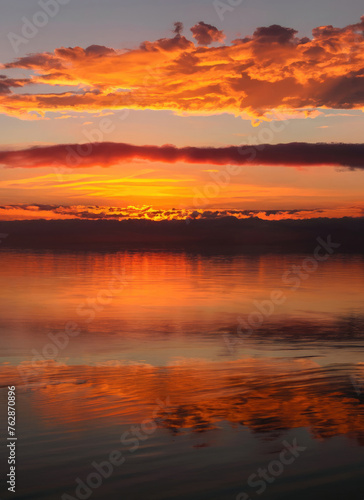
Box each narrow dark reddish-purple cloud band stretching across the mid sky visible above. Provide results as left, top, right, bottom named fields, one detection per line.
left=0, top=142, right=364, bottom=169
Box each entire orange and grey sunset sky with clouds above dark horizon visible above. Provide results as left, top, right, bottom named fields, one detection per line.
left=0, top=0, right=364, bottom=220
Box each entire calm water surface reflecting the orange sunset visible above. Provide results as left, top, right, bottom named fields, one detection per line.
left=0, top=251, right=364, bottom=500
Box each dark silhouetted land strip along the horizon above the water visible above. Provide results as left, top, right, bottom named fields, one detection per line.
left=0, top=217, right=364, bottom=253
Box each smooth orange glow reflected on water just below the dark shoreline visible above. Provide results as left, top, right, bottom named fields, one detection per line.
left=0, top=251, right=364, bottom=324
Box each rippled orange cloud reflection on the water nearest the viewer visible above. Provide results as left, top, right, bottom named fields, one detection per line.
left=0, top=359, right=364, bottom=445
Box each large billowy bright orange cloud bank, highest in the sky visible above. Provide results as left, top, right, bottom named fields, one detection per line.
left=0, top=16, right=364, bottom=117
